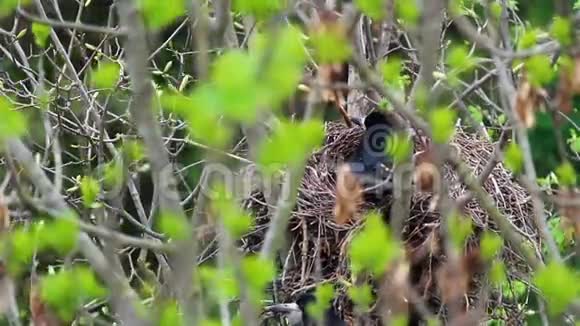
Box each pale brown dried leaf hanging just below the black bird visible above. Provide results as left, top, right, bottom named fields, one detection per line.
left=334, top=164, right=363, bottom=224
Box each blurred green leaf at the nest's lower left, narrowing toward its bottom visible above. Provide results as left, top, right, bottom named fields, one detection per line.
left=242, top=256, right=276, bottom=303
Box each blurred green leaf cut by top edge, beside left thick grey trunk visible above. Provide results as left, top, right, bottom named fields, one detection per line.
left=139, top=0, right=187, bottom=29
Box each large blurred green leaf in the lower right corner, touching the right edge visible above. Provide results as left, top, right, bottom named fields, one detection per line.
left=534, top=261, right=579, bottom=316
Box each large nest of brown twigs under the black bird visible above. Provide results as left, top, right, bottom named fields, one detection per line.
left=242, top=122, right=541, bottom=323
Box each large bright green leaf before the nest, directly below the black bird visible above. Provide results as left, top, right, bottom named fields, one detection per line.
left=349, top=212, right=401, bottom=275
